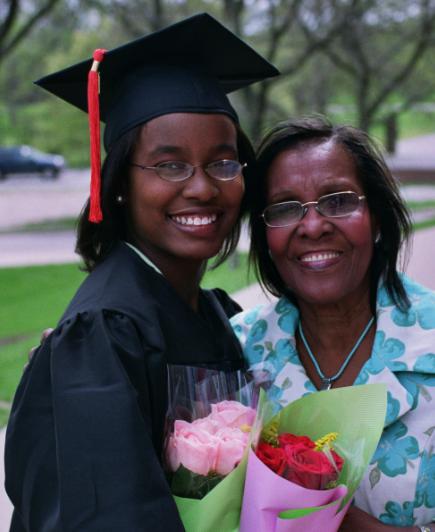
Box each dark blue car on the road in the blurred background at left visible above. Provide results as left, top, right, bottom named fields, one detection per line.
left=0, top=146, right=65, bottom=180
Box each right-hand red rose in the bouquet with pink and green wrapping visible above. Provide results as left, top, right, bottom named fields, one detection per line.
left=283, top=443, right=343, bottom=489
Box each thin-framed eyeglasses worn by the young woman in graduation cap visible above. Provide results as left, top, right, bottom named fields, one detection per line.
left=130, top=159, right=247, bottom=181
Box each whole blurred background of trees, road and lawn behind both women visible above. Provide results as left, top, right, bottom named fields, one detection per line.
left=0, top=0, right=435, bottom=532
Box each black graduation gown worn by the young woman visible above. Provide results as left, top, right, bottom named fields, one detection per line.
left=5, top=244, right=243, bottom=532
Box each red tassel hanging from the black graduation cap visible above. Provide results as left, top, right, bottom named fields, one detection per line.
left=88, top=49, right=106, bottom=223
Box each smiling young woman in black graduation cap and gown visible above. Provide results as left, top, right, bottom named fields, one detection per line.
left=6, top=15, right=277, bottom=532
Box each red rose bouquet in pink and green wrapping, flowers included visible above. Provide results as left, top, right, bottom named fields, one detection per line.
left=239, top=384, right=386, bottom=532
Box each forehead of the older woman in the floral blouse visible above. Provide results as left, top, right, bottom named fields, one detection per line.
left=267, top=139, right=361, bottom=199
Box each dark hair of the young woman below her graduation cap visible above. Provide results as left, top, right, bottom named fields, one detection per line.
left=76, top=120, right=255, bottom=272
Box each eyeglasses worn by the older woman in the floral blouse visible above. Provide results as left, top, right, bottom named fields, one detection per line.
left=261, top=190, right=365, bottom=227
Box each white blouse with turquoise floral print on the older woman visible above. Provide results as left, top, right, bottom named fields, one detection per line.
left=231, top=276, right=435, bottom=527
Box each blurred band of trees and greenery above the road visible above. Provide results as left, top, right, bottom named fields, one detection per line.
left=0, top=0, right=435, bottom=160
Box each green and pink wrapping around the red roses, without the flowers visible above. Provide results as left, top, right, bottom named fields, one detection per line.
left=240, top=384, right=387, bottom=532
